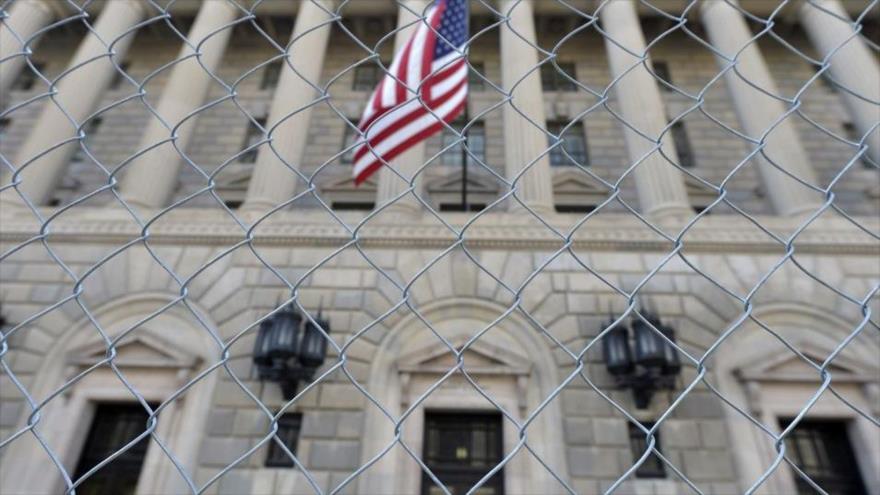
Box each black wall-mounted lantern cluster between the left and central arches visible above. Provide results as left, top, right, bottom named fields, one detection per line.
left=253, top=304, right=330, bottom=400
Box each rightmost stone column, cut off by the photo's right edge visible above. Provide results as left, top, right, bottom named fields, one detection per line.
left=800, top=0, right=880, bottom=164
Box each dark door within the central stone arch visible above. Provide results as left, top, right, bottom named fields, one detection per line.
left=422, top=412, right=504, bottom=495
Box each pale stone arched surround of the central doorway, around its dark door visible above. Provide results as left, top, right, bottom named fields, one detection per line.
left=358, top=298, right=567, bottom=495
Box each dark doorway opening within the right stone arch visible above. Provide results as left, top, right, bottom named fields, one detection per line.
left=780, top=420, right=867, bottom=495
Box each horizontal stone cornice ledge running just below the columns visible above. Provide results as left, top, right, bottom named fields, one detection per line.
left=0, top=208, right=880, bottom=256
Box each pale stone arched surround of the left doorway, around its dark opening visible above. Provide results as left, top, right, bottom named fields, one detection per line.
left=0, top=294, right=219, bottom=494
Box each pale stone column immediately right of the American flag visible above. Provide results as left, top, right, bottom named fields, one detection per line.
left=498, top=0, right=553, bottom=213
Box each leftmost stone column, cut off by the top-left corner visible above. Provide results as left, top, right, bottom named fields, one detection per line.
left=0, top=0, right=55, bottom=101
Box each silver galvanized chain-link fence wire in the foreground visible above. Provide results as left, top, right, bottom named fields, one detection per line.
left=0, top=0, right=880, bottom=494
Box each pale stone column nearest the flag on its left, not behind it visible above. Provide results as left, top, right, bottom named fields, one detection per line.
left=242, top=0, right=335, bottom=210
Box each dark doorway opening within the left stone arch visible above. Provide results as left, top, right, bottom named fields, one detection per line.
left=73, top=403, right=152, bottom=495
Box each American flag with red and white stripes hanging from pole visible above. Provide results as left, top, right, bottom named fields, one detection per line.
left=353, top=0, right=468, bottom=184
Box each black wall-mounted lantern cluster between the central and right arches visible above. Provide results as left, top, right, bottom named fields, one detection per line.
left=602, top=311, right=681, bottom=409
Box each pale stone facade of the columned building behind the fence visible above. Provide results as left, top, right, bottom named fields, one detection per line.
left=0, top=0, right=880, bottom=495
